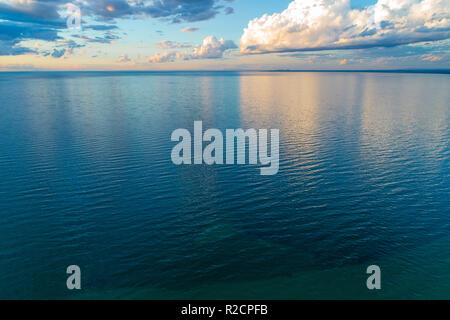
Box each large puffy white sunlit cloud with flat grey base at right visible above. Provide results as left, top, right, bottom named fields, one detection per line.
left=240, top=0, right=450, bottom=53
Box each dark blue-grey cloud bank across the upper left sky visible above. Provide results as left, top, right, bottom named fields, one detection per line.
left=0, top=0, right=229, bottom=55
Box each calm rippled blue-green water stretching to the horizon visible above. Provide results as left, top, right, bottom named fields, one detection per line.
left=0, top=72, right=450, bottom=299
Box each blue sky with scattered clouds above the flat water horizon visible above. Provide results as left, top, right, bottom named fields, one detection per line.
left=0, top=0, right=450, bottom=71
